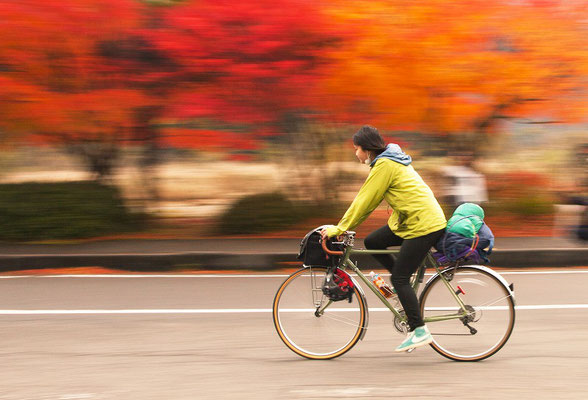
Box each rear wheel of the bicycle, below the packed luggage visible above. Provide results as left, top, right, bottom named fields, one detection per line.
left=421, top=266, right=515, bottom=361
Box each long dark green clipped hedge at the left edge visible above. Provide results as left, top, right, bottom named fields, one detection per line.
left=0, top=182, right=145, bottom=241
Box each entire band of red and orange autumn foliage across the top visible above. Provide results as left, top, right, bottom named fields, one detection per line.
left=0, top=0, right=588, bottom=155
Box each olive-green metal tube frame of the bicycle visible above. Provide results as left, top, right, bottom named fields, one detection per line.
left=336, top=246, right=469, bottom=323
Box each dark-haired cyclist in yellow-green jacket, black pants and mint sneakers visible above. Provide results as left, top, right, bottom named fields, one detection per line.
left=321, top=125, right=447, bottom=352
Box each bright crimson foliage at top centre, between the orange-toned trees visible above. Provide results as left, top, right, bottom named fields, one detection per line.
left=143, top=0, right=333, bottom=123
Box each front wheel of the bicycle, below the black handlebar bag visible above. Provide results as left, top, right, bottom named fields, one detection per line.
left=273, top=267, right=367, bottom=360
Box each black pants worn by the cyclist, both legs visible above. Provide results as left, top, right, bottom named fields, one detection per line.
left=364, top=225, right=445, bottom=331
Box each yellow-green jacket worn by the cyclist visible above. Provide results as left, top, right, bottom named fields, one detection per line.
left=327, top=158, right=447, bottom=239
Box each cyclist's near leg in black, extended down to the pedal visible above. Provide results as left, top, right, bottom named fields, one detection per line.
left=392, top=229, right=444, bottom=331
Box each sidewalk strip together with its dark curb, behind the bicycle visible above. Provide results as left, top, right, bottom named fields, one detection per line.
left=0, top=237, right=588, bottom=272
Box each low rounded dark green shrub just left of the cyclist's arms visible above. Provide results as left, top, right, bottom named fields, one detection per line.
left=218, top=192, right=340, bottom=235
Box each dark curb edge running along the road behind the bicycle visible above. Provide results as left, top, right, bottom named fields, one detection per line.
left=0, top=248, right=588, bottom=272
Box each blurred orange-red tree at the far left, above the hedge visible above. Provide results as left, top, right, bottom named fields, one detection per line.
left=0, top=0, right=150, bottom=179
